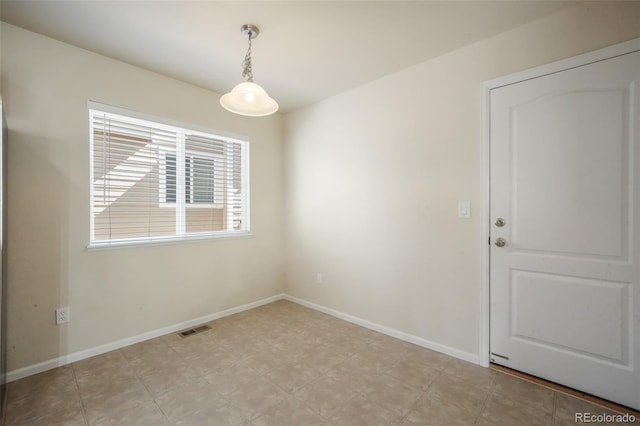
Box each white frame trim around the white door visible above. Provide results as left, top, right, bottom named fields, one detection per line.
left=478, top=38, right=640, bottom=367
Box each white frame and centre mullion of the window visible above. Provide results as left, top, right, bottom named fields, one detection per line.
left=87, top=101, right=253, bottom=250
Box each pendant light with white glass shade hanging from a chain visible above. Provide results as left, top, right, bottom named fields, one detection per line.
left=220, top=24, right=278, bottom=117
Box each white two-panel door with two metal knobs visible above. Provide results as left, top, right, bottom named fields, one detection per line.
left=489, top=47, right=640, bottom=409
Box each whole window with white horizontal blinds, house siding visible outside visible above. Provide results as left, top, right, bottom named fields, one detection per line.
left=89, top=103, right=249, bottom=247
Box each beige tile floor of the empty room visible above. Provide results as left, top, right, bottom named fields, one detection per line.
left=6, top=301, right=640, bottom=426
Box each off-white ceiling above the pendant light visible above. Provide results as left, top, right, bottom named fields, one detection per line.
left=0, top=0, right=571, bottom=112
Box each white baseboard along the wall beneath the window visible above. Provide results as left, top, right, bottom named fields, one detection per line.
left=6, top=294, right=285, bottom=382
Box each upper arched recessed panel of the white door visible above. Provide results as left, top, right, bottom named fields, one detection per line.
left=511, top=87, right=631, bottom=258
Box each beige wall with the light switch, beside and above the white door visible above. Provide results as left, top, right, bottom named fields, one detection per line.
left=285, top=2, right=640, bottom=359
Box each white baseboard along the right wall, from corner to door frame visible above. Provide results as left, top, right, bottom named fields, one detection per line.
left=283, top=294, right=480, bottom=365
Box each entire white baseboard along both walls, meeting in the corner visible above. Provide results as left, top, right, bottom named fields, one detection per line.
left=6, top=293, right=480, bottom=382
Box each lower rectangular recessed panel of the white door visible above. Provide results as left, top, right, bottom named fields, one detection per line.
left=511, top=271, right=631, bottom=365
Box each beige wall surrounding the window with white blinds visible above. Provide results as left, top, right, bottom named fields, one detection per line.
left=1, top=23, right=284, bottom=371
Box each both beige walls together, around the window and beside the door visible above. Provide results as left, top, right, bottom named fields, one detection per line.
left=0, top=2, right=640, bottom=376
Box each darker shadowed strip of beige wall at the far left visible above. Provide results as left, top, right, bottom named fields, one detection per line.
left=7, top=130, right=71, bottom=371
